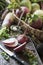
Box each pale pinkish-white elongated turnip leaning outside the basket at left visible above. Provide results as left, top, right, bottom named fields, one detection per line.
left=2, top=12, right=14, bottom=27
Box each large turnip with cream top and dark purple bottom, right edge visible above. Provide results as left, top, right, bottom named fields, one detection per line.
left=30, top=10, right=43, bottom=29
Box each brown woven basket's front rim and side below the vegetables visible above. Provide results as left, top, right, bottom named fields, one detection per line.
left=15, top=15, right=43, bottom=41
